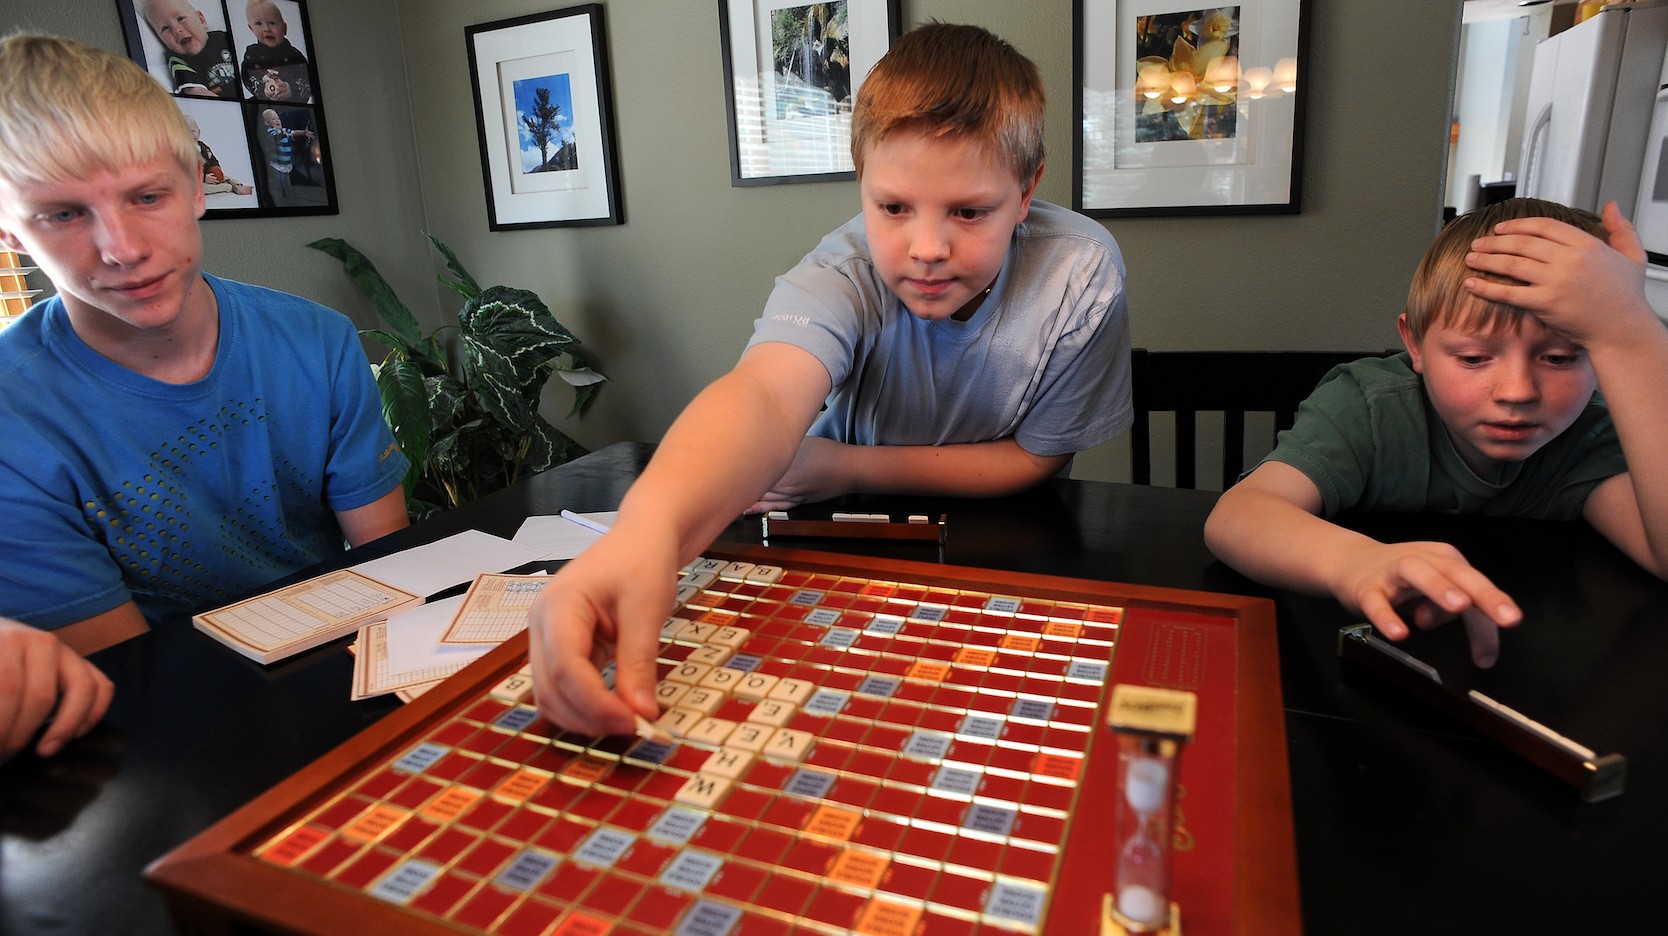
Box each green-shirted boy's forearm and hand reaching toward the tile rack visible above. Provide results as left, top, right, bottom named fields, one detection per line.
left=1204, top=462, right=1523, bottom=667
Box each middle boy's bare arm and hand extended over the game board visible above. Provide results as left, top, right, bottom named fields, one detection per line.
left=529, top=342, right=829, bottom=734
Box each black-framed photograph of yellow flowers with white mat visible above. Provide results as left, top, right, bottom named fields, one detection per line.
left=1073, top=0, right=1309, bottom=217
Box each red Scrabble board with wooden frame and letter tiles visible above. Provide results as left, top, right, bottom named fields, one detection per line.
left=147, top=544, right=1301, bottom=936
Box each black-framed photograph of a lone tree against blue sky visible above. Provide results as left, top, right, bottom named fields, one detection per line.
left=464, top=3, right=624, bottom=230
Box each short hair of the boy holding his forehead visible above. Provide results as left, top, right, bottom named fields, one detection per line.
left=1406, top=199, right=1608, bottom=342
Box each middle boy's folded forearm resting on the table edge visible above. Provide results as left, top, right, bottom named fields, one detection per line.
left=749, top=437, right=1071, bottom=512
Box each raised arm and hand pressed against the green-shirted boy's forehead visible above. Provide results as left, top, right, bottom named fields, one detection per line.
left=1466, top=202, right=1668, bottom=579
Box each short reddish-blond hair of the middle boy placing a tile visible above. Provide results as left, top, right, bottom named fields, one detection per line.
left=851, top=23, right=1044, bottom=185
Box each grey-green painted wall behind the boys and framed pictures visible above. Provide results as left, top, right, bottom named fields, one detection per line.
left=7, top=0, right=1460, bottom=481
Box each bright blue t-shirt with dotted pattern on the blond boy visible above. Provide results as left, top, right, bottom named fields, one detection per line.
left=0, top=277, right=407, bottom=627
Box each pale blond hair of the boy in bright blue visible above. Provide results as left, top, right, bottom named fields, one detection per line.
left=0, top=33, right=197, bottom=185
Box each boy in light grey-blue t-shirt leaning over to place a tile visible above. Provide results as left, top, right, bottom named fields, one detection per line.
left=529, top=23, right=1133, bottom=734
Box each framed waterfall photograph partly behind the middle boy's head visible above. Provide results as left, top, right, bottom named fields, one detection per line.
left=719, top=0, right=899, bottom=185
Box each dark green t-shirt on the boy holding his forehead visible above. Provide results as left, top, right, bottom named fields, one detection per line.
left=1264, top=352, right=1628, bottom=521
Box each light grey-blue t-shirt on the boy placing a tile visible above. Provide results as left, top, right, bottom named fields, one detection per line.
left=747, top=200, right=1134, bottom=455
